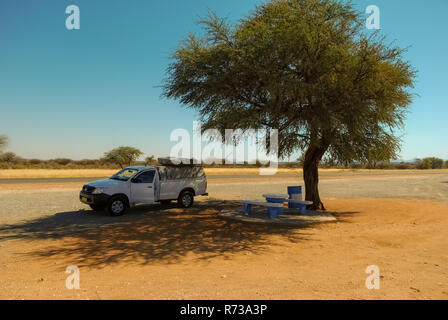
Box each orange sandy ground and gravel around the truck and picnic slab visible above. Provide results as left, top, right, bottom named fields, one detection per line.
left=0, top=174, right=448, bottom=299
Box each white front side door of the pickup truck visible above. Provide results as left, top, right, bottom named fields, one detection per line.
left=131, top=170, right=158, bottom=204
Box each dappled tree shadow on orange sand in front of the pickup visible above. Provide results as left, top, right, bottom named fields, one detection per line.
left=0, top=200, right=314, bottom=268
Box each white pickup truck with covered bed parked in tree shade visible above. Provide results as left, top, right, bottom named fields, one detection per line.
left=79, top=165, right=208, bottom=216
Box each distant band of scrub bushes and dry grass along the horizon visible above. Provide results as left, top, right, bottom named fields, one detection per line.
left=0, top=135, right=448, bottom=171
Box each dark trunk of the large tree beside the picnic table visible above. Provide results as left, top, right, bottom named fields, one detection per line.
left=303, top=145, right=327, bottom=210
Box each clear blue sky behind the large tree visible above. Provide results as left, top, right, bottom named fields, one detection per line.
left=0, top=0, right=448, bottom=159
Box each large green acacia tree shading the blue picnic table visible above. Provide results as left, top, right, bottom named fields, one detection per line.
left=164, top=0, right=415, bottom=209
